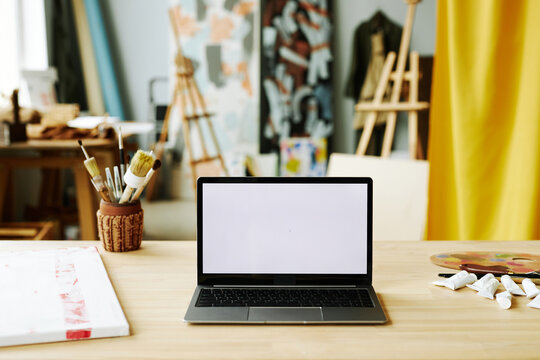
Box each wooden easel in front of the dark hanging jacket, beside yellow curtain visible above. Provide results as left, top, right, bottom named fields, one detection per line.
left=355, top=0, right=429, bottom=159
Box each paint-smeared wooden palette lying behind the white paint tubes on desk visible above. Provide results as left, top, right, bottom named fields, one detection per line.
left=430, top=251, right=540, bottom=273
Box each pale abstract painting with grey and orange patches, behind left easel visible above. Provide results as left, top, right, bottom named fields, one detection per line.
left=173, top=0, right=259, bottom=175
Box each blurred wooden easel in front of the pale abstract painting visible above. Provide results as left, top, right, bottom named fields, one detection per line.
left=146, top=6, right=229, bottom=201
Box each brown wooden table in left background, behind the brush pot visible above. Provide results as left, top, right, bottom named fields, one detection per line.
left=0, top=139, right=118, bottom=240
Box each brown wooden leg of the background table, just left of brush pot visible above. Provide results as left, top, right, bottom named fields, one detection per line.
left=73, top=165, right=97, bottom=240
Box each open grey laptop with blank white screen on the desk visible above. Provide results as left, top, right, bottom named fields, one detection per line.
left=184, top=177, right=387, bottom=324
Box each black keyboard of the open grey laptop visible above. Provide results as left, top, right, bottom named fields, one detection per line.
left=195, top=288, right=373, bottom=307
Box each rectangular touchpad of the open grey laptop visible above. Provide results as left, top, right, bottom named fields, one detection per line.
left=248, top=307, right=323, bottom=322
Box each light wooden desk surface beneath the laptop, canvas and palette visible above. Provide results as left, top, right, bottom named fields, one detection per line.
left=0, top=241, right=540, bottom=359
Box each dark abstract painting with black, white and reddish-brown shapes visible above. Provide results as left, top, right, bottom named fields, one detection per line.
left=259, top=0, right=333, bottom=153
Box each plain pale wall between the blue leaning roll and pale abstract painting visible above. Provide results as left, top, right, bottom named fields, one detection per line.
left=101, top=0, right=170, bottom=121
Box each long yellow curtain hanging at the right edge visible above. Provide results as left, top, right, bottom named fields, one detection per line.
left=427, top=0, right=540, bottom=240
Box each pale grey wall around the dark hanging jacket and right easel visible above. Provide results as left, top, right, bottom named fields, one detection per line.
left=333, top=0, right=437, bottom=153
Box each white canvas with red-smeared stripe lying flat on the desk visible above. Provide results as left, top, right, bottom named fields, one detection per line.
left=0, top=247, right=129, bottom=346
